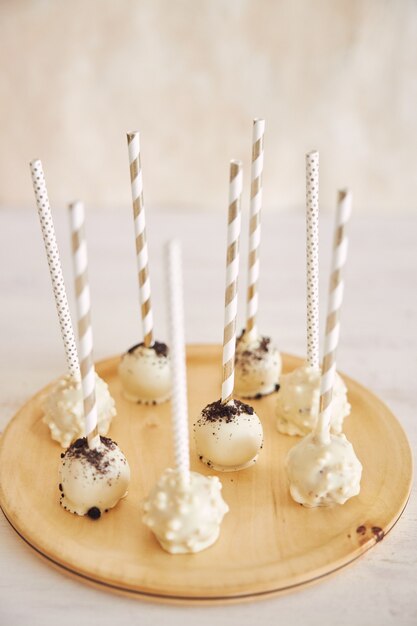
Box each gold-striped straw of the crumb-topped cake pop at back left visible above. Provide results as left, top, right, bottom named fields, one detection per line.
left=127, top=131, right=153, bottom=348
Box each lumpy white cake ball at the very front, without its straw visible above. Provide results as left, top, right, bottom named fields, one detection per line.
left=143, top=469, right=229, bottom=554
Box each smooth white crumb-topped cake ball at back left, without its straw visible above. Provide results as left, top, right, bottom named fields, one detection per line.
left=119, top=344, right=171, bottom=404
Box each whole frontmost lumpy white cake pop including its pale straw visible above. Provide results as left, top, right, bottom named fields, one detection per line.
left=143, top=241, right=229, bottom=554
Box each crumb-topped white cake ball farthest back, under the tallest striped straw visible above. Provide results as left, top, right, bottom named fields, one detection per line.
left=235, top=332, right=282, bottom=398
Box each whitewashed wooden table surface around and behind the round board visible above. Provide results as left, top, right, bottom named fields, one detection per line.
left=0, top=207, right=417, bottom=626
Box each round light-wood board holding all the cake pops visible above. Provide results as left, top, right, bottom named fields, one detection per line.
left=0, top=345, right=412, bottom=604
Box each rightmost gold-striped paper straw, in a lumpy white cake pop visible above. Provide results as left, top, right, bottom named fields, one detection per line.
left=316, top=190, right=352, bottom=440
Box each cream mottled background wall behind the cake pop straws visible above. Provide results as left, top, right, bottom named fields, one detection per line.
left=0, top=0, right=417, bottom=212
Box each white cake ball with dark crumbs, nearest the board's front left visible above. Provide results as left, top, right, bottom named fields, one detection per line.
left=59, top=437, right=130, bottom=515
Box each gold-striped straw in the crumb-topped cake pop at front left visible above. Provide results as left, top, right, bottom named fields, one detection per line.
left=69, top=202, right=100, bottom=449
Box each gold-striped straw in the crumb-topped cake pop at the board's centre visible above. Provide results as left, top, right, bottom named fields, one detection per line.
left=222, top=161, right=243, bottom=403
